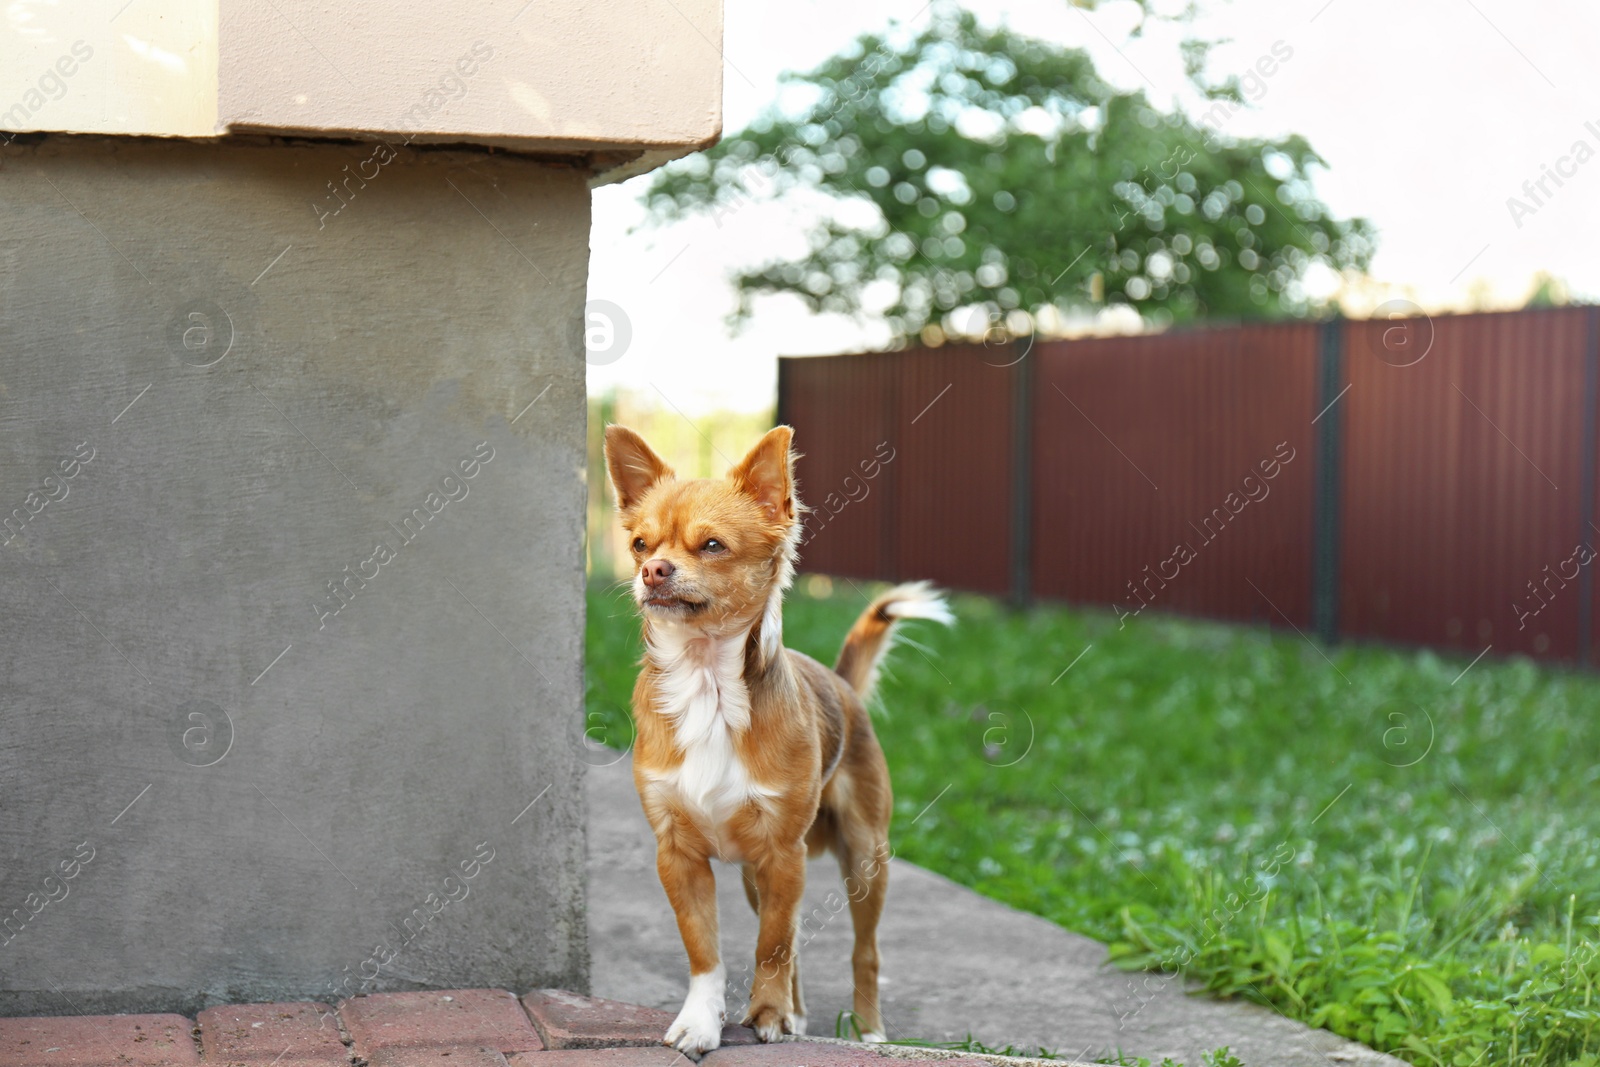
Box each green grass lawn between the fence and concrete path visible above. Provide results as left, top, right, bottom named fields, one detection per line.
left=589, top=581, right=1600, bottom=1067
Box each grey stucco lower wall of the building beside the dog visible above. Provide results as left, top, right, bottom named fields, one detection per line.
left=0, top=138, right=589, bottom=1014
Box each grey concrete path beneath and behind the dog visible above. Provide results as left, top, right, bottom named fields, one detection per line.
left=587, top=758, right=1405, bottom=1067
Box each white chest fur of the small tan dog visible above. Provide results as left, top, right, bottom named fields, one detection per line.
left=646, top=625, right=776, bottom=861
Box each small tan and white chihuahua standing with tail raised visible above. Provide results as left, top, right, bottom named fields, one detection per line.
left=605, top=426, right=952, bottom=1059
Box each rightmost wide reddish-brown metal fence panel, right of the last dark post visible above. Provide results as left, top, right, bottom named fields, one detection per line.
left=1339, top=309, right=1600, bottom=659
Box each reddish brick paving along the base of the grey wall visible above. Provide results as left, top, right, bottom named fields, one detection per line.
left=0, top=989, right=1011, bottom=1067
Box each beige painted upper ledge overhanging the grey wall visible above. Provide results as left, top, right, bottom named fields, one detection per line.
left=0, top=0, right=722, bottom=168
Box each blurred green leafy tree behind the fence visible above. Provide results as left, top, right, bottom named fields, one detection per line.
left=646, top=8, right=1374, bottom=338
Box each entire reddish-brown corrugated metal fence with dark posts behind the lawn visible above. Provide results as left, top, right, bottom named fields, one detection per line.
left=779, top=309, right=1600, bottom=659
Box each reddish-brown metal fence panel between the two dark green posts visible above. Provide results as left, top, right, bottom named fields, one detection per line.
left=1034, top=323, right=1317, bottom=627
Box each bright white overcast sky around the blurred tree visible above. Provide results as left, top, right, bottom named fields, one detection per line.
left=589, top=0, right=1600, bottom=413
